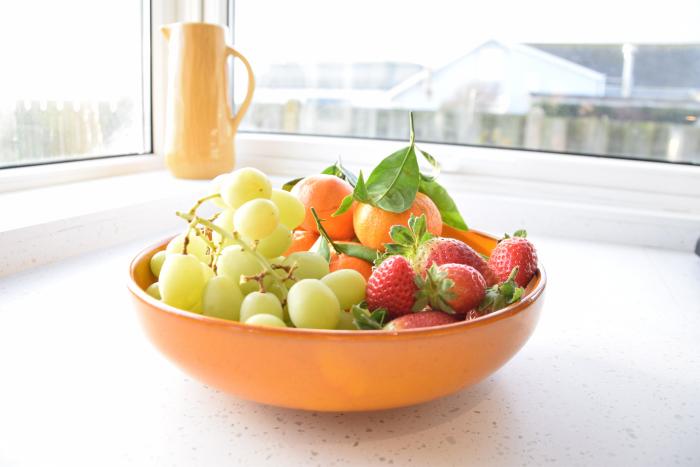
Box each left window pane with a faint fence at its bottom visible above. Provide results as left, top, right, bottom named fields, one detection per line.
left=0, top=0, right=150, bottom=167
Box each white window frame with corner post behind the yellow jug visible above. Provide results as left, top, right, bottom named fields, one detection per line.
left=0, top=0, right=700, bottom=210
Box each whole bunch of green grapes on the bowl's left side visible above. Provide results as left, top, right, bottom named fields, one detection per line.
left=146, top=168, right=366, bottom=329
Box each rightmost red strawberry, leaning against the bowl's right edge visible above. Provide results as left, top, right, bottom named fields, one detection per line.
left=488, top=230, right=537, bottom=287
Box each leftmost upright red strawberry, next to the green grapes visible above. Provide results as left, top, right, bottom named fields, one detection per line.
left=367, top=256, right=418, bottom=319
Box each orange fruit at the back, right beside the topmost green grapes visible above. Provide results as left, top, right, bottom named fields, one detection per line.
left=292, top=174, right=354, bottom=240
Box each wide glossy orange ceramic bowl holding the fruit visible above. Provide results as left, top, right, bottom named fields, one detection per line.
left=129, top=227, right=546, bottom=411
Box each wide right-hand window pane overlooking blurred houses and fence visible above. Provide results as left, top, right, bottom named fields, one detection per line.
left=235, top=0, right=700, bottom=164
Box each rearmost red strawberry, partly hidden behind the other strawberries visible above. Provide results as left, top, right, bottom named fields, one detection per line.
left=413, top=237, right=498, bottom=286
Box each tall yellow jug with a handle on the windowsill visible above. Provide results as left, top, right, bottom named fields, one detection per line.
left=161, top=23, right=255, bottom=179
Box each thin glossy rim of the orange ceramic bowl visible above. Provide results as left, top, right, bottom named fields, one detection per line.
left=127, top=229, right=547, bottom=340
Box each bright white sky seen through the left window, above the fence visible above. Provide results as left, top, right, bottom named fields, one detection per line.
left=0, top=0, right=142, bottom=102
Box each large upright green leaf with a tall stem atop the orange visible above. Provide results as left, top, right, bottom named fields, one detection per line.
left=367, top=146, right=420, bottom=213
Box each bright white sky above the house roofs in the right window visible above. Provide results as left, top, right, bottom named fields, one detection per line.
left=235, top=0, right=700, bottom=66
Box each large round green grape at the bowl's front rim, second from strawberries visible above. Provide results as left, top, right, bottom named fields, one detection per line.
left=287, top=279, right=340, bottom=329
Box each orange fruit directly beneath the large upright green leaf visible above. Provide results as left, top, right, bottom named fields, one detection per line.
left=353, top=192, right=442, bottom=251
